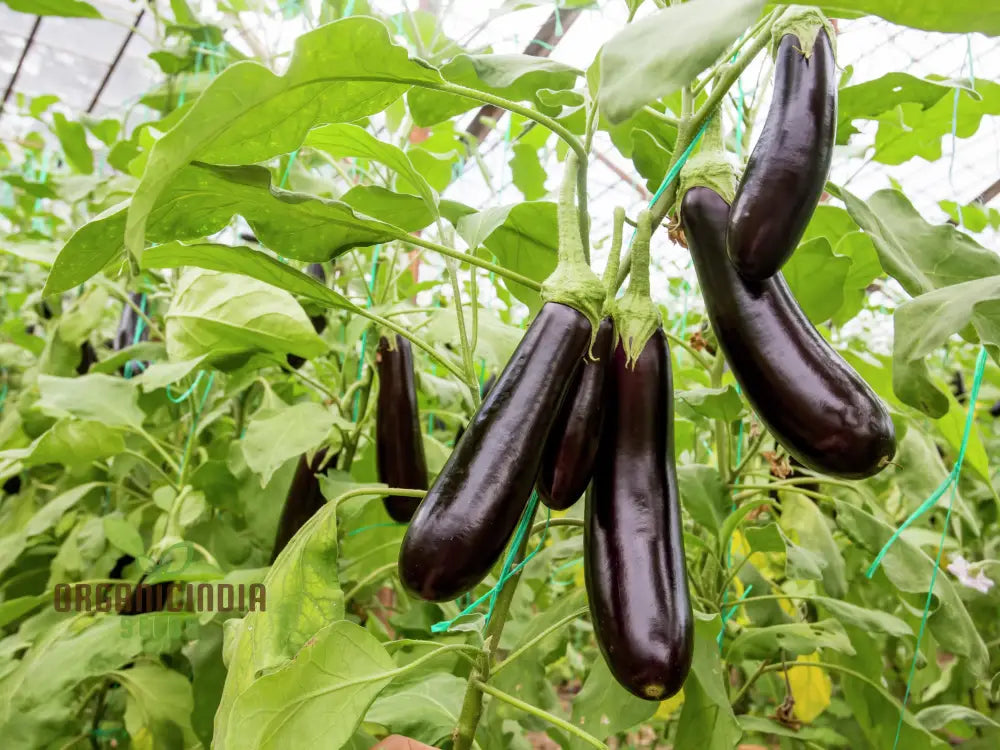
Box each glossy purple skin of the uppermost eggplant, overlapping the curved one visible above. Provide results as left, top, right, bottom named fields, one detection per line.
left=727, top=30, right=837, bottom=281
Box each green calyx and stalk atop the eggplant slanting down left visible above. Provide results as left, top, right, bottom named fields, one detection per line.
left=542, top=152, right=604, bottom=346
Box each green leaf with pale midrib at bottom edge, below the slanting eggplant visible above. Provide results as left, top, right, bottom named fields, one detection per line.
left=214, top=621, right=396, bottom=750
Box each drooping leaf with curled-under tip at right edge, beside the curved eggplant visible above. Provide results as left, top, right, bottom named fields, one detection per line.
left=892, top=276, right=1000, bottom=418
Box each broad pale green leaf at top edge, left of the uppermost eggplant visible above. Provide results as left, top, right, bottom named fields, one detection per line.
left=599, top=0, right=764, bottom=123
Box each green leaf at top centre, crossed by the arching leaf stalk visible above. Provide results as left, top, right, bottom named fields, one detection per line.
left=406, top=54, right=580, bottom=127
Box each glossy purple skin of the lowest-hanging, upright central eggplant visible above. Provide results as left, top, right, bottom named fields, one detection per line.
left=583, top=329, right=694, bottom=700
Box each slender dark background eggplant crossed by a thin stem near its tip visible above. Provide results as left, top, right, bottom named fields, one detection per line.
left=375, top=333, right=427, bottom=523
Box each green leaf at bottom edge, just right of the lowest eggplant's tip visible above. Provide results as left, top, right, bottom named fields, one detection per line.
left=674, top=612, right=743, bottom=750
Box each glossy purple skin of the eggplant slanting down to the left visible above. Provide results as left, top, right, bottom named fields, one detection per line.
left=399, top=302, right=591, bottom=601
